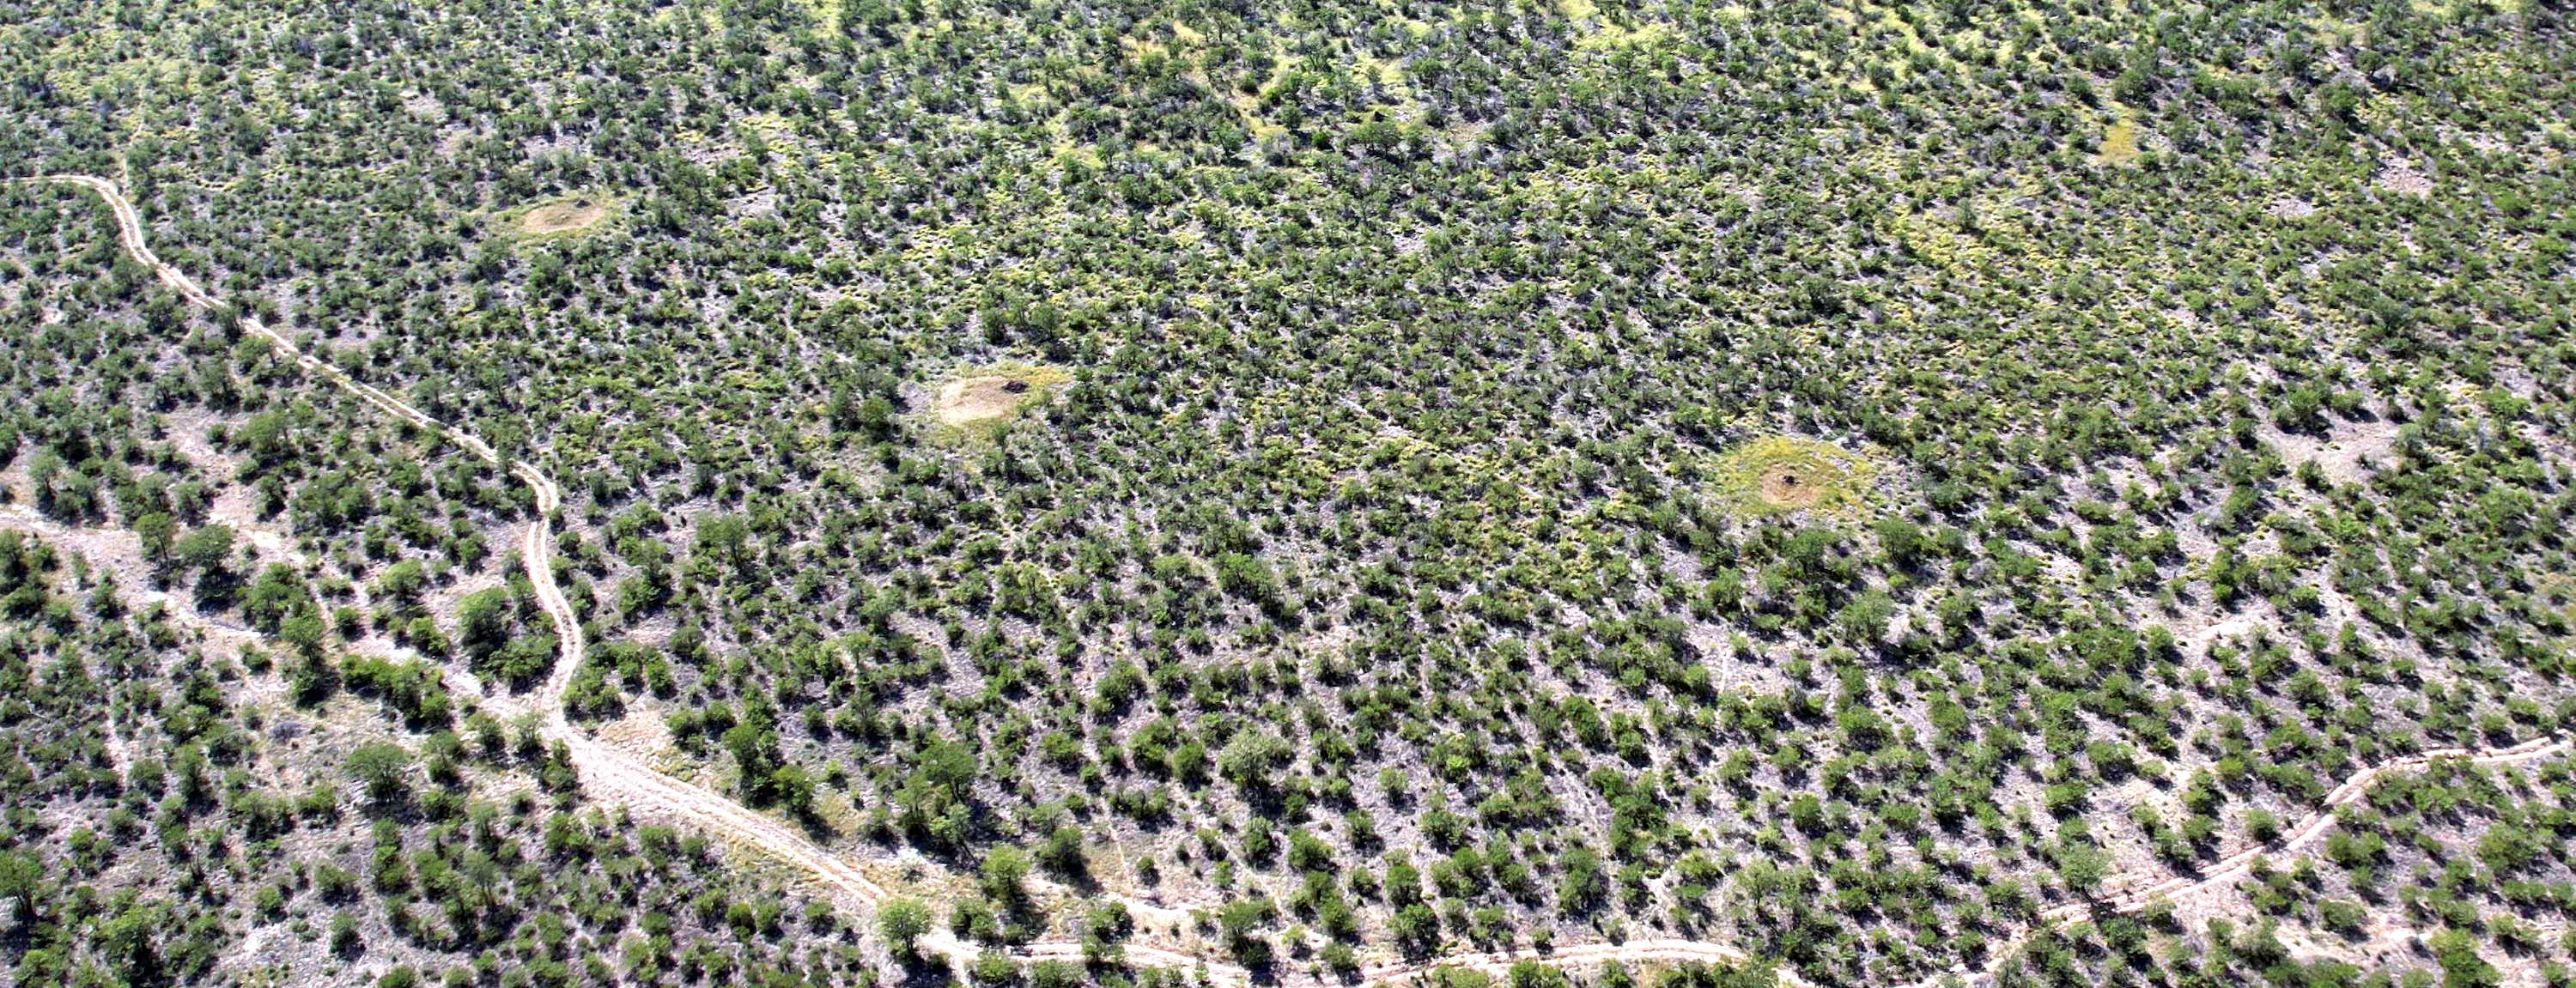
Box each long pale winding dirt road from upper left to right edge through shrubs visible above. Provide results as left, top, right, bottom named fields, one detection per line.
left=13, top=175, right=2568, bottom=988
